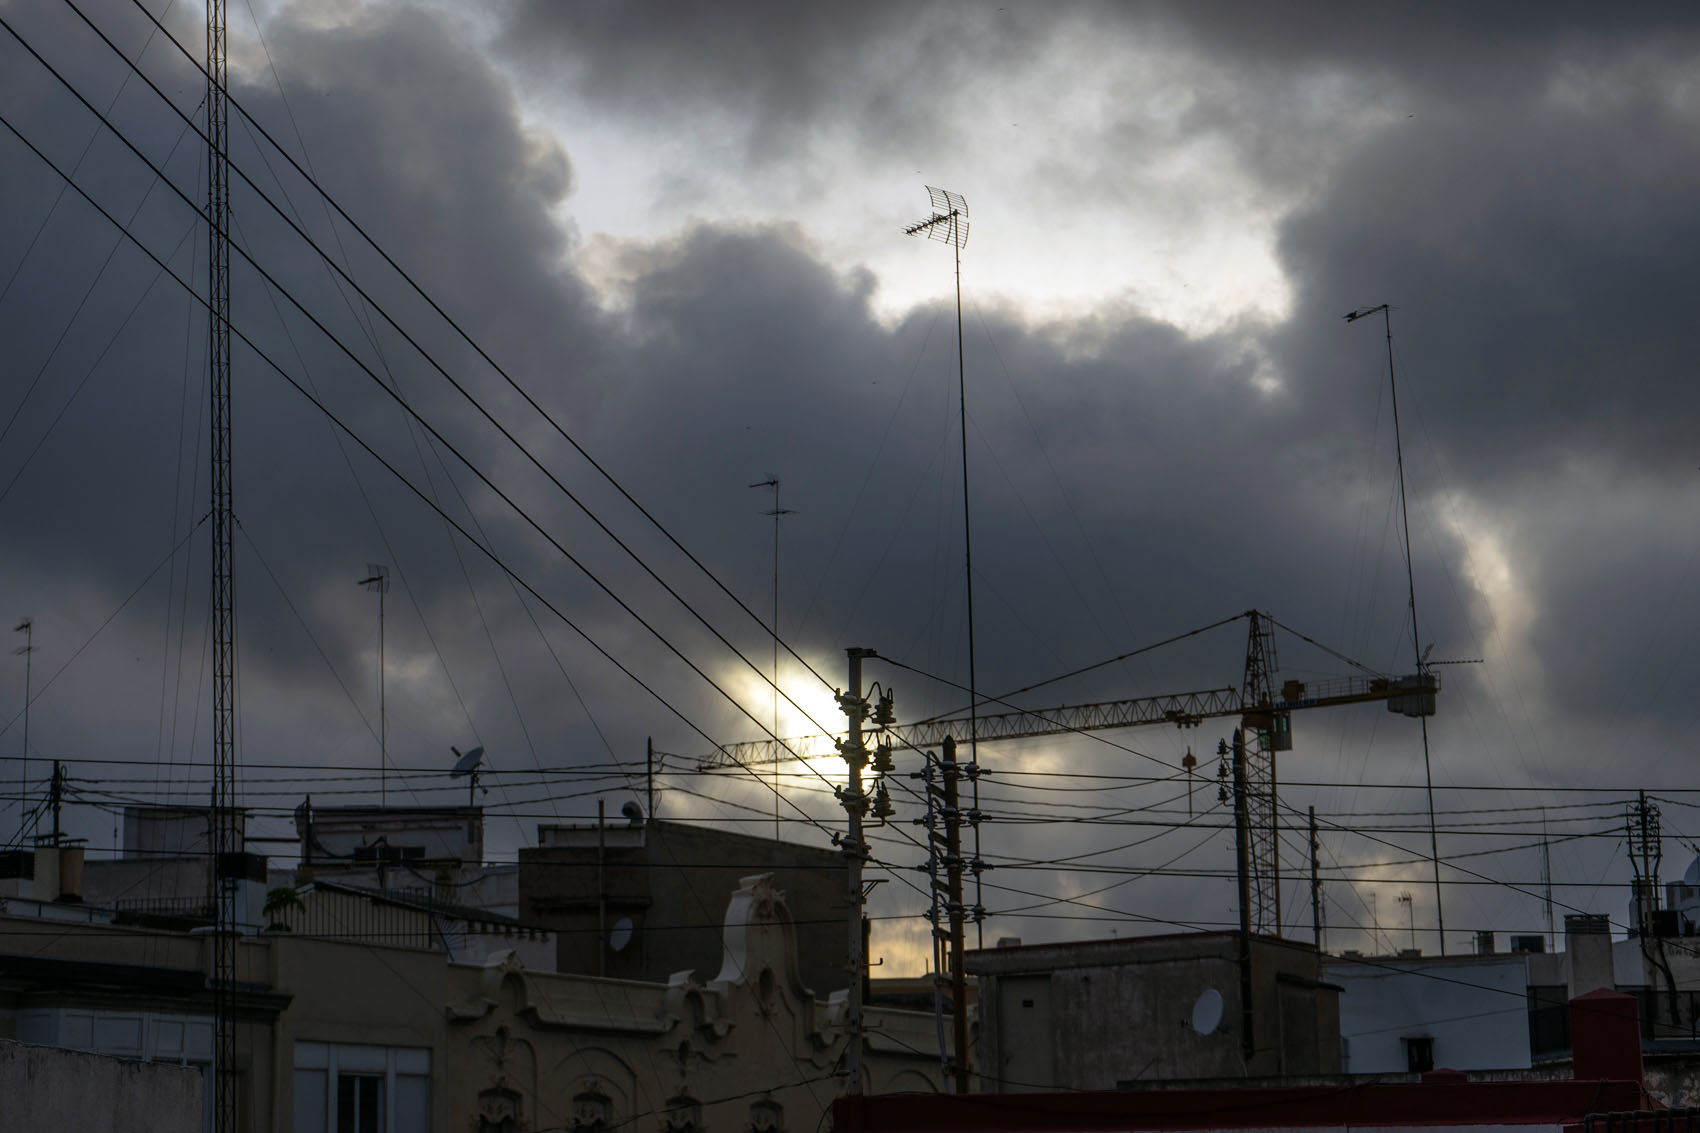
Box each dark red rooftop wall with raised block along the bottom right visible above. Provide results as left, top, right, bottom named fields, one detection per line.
left=833, top=990, right=1659, bottom=1133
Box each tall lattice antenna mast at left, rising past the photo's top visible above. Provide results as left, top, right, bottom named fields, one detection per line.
left=206, top=0, right=240, bottom=1133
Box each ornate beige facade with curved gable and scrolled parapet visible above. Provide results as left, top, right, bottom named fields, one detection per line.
left=447, top=878, right=938, bottom=1133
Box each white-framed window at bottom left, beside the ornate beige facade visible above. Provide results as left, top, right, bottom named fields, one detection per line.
left=294, top=1043, right=432, bottom=1133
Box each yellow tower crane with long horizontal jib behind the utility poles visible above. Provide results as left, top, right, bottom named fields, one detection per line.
left=697, top=611, right=1440, bottom=936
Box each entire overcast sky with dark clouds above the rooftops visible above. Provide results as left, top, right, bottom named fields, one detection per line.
left=0, top=0, right=1700, bottom=970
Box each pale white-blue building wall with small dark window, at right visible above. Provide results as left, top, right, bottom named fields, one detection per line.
left=1323, top=954, right=1530, bottom=1073
